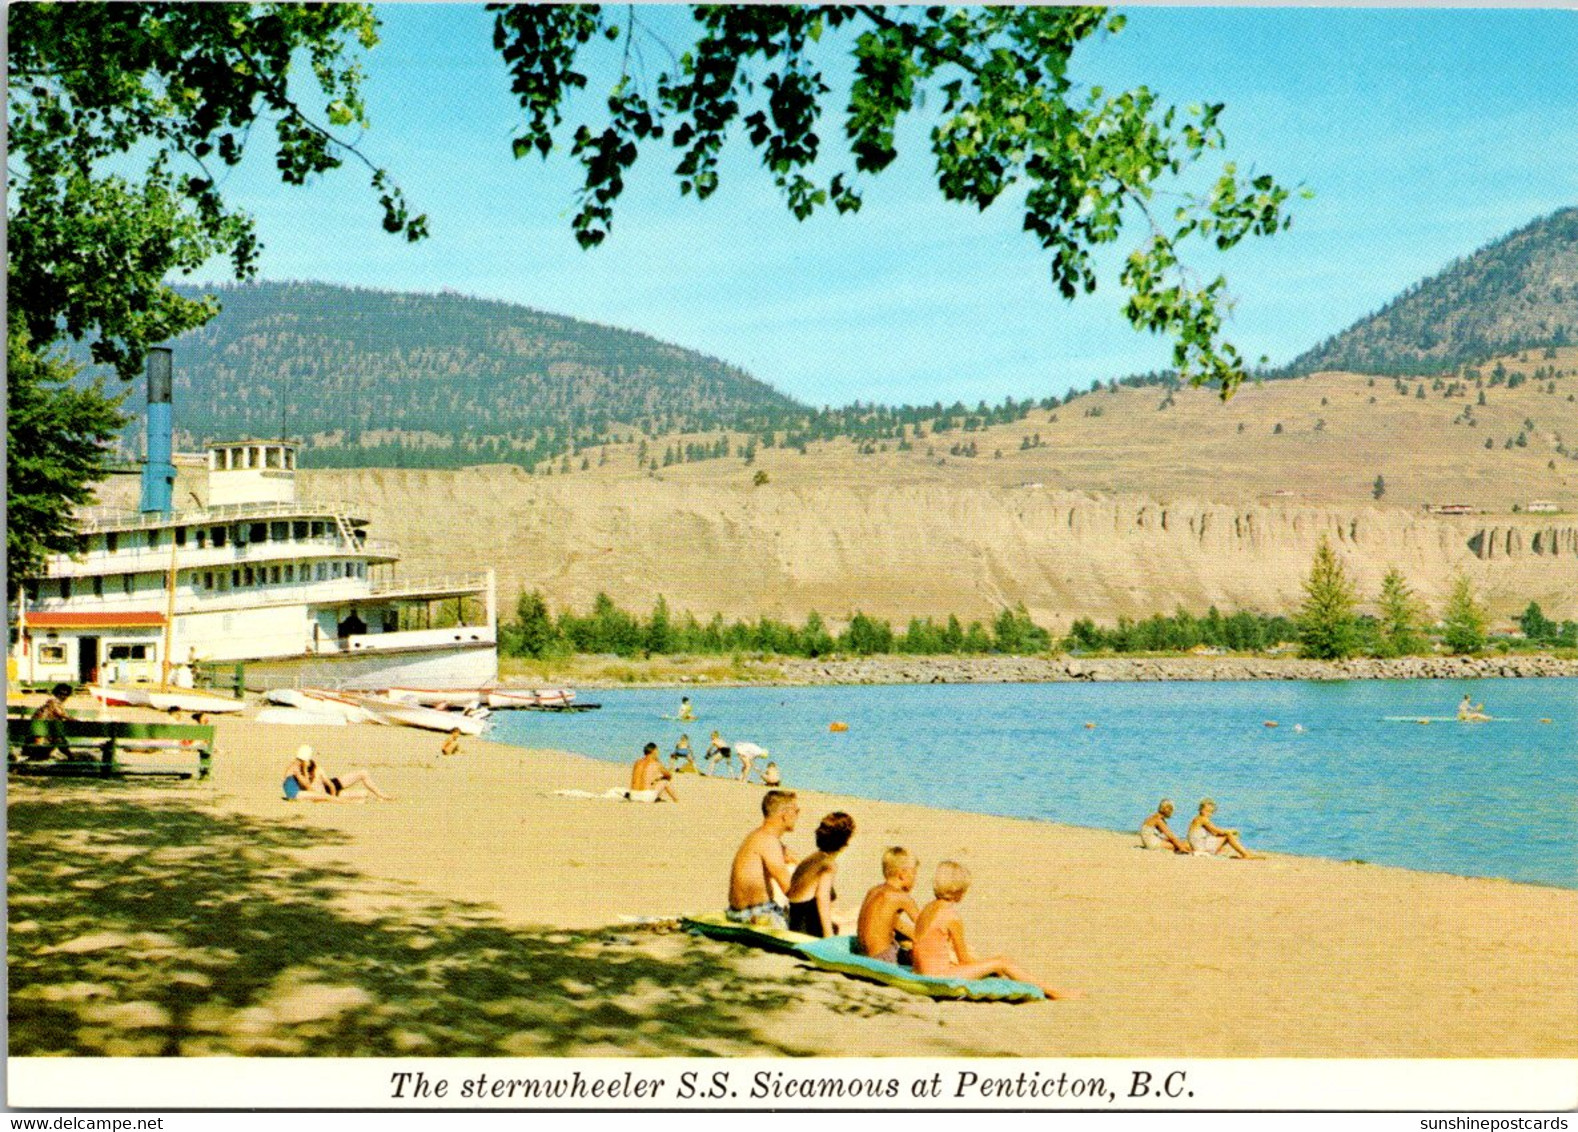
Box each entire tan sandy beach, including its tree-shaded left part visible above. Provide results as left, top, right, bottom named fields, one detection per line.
left=8, top=720, right=1578, bottom=1058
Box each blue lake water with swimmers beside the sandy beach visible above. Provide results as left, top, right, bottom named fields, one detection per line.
left=491, top=679, right=1578, bottom=887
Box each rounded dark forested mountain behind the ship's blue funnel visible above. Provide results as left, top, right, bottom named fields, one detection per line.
left=82, top=283, right=806, bottom=466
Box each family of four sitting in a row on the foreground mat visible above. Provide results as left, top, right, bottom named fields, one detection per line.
left=726, top=789, right=1075, bottom=998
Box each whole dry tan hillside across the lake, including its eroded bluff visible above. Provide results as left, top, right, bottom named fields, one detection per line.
left=277, top=349, right=1578, bottom=627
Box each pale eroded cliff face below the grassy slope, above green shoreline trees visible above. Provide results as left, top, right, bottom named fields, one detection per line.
left=301, top=467, right=1578, bottom=628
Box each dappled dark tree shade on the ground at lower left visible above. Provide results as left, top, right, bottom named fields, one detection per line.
left=8, top=783, right=808, bottom=1056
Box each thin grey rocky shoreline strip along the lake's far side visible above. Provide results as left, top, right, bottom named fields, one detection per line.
left=579, top=655, right=1578, bottom=687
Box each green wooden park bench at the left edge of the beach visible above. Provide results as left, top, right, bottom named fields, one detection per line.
left=6, top=720, right=213, bottom=778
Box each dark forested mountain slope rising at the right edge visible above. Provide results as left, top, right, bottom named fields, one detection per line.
left=1280, top=208, right=1578, bottom=376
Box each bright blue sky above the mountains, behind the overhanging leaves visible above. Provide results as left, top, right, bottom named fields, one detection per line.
left=187, top=5, right=1578, bottom=404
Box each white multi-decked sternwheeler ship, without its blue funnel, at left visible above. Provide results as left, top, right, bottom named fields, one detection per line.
left=13, top=429, right=499, bottom=687
